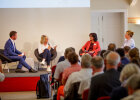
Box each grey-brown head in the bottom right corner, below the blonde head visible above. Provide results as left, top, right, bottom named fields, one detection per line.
left=126, top=74, right=140, bottom=95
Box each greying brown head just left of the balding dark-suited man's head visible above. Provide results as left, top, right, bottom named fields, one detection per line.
left=91, top=56, right=104, bottom=69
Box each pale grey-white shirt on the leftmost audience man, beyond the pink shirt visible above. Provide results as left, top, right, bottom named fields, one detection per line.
left=54, top=59, right=71, bottom=79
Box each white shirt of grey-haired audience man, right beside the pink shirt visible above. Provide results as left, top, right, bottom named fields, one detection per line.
left=64, top=68, right=92, bottom=92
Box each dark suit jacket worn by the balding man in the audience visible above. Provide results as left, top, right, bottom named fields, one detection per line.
left=88, top=69, right=121, bottom=100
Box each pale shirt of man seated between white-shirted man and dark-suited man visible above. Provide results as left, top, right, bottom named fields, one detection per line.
left=78, top=71, right=104, bottom=95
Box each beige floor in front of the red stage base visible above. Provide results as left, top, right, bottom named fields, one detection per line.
left=0, top=91, right=51, bottom=100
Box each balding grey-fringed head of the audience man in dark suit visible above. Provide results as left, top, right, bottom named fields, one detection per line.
left=106, top=51, right=120, bottom=70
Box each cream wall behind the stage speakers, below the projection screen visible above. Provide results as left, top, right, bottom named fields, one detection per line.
left=0, top=8, right=90, bottom=62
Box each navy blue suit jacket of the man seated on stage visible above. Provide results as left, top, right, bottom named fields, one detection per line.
left=4, top=39, right=22, bottom=56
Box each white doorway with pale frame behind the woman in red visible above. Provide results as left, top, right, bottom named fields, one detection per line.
left=91, top=10, right=127, bottom=49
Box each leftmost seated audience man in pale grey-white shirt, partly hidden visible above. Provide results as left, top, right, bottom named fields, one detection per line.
left=54, top=47, right=75, bottom=81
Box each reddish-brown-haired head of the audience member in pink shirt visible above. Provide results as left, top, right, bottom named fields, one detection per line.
left=68, top=52, right=79, bottom=65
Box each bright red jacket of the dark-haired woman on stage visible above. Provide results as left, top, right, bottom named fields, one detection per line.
left=82, top=41, right=101, bottom=56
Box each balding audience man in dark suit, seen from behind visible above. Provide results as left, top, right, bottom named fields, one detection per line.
left=88, top=52, right=121, bottom=100
